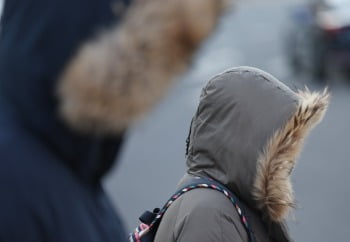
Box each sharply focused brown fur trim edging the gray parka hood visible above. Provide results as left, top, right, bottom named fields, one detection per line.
left=253, top=89, right=329, bottom=222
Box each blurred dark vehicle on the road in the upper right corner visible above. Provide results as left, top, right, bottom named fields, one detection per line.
left=287, top=0, right=350, bottom=81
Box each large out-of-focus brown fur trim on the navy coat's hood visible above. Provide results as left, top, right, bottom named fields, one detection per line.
left=57, top=0, right=226, bottom=134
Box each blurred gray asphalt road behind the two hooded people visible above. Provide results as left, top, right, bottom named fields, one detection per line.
left=105, top=0, right=350, bottom=242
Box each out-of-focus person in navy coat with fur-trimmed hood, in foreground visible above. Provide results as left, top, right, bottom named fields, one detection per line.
left=0, top=0, right=224, bottom=242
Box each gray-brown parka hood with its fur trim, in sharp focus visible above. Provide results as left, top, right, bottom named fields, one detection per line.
left=187, top=67, right=329, bottom=222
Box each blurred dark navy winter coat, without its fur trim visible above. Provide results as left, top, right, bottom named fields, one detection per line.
left=0, top=0, right=130, bottom=242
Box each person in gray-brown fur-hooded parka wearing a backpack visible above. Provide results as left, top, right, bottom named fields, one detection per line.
left=155, top=67, right=329, bottom=242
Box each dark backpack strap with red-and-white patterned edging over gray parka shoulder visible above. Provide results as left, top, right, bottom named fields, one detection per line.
left=129, top=177, right=256, bottom=242
